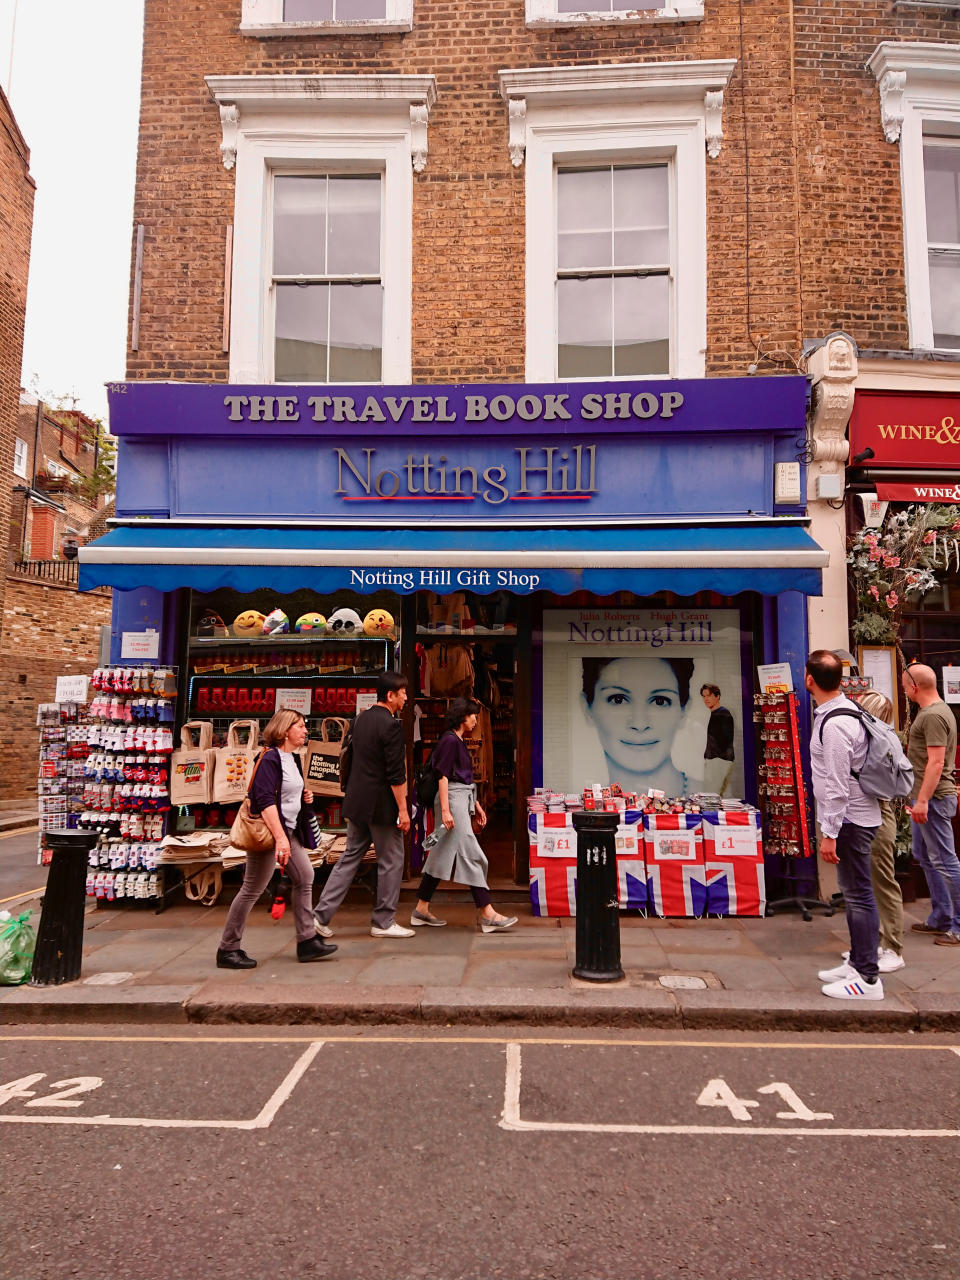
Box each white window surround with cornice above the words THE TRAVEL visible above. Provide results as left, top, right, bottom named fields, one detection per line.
left=206, top=76, right=436, bottom=384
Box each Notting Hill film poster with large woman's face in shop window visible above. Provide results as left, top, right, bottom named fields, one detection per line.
left=543, top=608, right=744, bottom=797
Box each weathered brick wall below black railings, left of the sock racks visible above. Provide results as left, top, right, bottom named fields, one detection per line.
left=0, top=576, right=110, bottom=800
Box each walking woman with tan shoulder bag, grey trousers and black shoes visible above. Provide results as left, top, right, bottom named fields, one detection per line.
left=216, top=710, right=337, bottom=969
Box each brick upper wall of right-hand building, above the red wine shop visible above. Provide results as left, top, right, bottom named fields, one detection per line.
left=795, top=0, right=960, bottom=349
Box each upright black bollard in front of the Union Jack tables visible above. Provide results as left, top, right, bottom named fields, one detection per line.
left=573, top=810, right=623, bottom=982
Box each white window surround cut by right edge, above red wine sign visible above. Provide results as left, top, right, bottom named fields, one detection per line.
left=867, top=41, right=960, bottom=352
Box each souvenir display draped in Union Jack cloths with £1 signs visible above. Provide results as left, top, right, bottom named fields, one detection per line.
left=527, top=783, right=767, bottom=916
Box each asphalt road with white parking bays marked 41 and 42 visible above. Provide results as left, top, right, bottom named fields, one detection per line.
left=0, top=1027, right=960, bottom=1280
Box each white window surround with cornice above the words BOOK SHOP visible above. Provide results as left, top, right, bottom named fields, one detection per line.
left=500, top=60, right=736, bottom=383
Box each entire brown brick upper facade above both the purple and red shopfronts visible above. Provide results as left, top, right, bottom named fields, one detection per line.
left=128, top=0, right=960, bottom=381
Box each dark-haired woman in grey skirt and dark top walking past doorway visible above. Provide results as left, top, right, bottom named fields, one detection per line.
left=410, top=698, right=517, bottom=933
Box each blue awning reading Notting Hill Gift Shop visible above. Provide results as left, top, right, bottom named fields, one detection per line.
left=79, top=521, right=828, bottom=595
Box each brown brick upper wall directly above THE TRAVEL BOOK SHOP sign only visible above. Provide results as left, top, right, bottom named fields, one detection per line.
left=128, top=0, right=870, bottom=381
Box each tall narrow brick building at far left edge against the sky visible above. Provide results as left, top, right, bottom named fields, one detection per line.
left=0, top=90, right=35, bottom=635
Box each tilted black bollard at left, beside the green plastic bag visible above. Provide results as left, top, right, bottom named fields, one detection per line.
left=29, top=831, right=97, bottom=987
